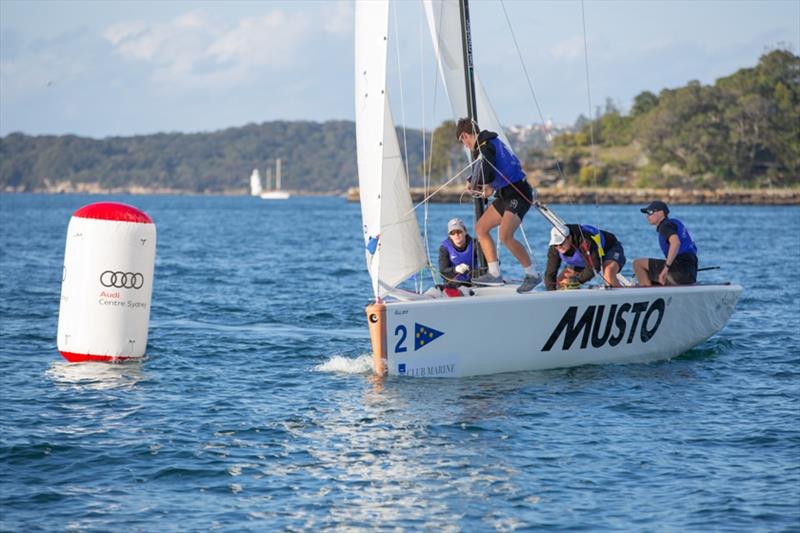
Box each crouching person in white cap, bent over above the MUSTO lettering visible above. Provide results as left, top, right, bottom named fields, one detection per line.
left=544, top=224, right=625, bottom=291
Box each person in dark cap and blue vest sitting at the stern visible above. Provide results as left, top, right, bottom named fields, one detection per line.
left=633, top=200, right=697, bottom=287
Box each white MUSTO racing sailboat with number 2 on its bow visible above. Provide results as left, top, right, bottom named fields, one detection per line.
left=355, top=0, right=742, bottom=377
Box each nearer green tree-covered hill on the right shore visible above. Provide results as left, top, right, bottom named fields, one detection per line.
left=538, top=50, right=800, bottom=189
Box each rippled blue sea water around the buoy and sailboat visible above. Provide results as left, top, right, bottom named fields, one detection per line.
left=0, top=195, right=800, bottom=531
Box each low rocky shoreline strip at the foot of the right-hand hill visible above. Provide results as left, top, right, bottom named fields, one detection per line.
left=347, top=186, right=800, bottom=205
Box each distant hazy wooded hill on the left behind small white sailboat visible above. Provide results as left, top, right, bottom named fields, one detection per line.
left=0, top=121, right=422, bottom=193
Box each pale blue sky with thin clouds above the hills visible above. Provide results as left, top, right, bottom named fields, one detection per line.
left=0, top=0, right=800, bottom=138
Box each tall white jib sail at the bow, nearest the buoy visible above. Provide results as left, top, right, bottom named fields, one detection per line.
left=355, top=0, right=427, bottom=298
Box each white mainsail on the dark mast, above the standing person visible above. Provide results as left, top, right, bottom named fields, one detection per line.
left=423, top=0, right=511, bottom=149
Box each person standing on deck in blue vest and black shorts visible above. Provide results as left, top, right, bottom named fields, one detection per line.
left=456, top=118, right=542, bottom=293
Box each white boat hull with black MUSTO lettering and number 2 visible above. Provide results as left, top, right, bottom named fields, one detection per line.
left=367, top=285, right=742, bottom=377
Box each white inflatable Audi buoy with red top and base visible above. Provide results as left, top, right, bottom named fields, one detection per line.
left=58, top=202, right=156, bottom=362
